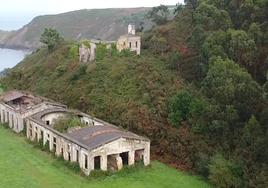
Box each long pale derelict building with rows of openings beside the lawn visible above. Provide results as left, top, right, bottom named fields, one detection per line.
left=0, top=91, right=150, bottom=175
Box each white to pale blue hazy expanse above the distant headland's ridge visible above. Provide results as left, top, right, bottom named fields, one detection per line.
left=0, top=0, right=183, bottom=30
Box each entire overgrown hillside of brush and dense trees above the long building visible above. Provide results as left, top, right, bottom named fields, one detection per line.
left=2, top=0, right=268, bottom=187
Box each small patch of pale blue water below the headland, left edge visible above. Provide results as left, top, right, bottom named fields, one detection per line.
left=0, top=48, right=29, bottom=72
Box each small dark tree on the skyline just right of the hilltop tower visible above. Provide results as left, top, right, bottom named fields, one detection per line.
left=146, top=5, right=169, bottom=25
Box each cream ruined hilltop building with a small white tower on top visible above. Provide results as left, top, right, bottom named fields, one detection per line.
left=116, top=24, right=141, bottom=55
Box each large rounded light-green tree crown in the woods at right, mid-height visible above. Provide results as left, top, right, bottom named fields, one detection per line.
left=202, top=58, right=263, bottom=119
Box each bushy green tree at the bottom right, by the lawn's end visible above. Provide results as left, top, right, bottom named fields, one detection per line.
left=208, top=154, right=243, bottom=188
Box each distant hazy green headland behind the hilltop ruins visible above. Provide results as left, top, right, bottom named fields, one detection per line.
left=0, top=8, right=152, bottom=48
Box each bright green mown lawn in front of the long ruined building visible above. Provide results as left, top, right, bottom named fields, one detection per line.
left=0, top=126, right=210, bottom=188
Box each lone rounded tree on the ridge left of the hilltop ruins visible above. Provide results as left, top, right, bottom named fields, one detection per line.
left=40, top=28, right=63, bottom=51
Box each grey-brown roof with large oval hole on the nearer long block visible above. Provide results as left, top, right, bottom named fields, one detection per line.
left=29, top=107, right=149, bottom=150
